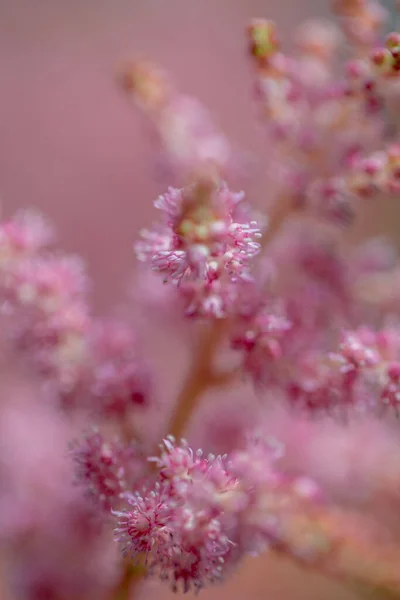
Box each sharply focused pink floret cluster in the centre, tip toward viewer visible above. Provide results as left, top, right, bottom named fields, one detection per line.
left=136, top=184, right=261, bottom=318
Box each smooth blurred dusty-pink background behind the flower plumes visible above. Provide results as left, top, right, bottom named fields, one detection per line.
left=0, top=0, right=399, bottom=600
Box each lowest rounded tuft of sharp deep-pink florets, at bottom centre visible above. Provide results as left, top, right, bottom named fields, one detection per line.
left=115, top=488, right=231, bottom=592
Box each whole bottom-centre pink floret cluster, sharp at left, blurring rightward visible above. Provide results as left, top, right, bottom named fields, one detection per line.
left=114, top=438, right=319, bottom=592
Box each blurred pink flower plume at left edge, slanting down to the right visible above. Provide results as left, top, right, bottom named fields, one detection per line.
left=0, top=213, right=151, bottom=418
